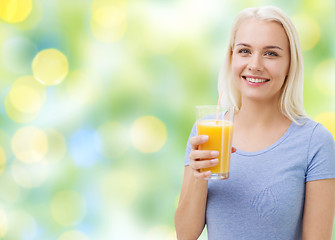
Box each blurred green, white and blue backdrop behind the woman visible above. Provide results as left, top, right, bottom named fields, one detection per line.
left=0, top=0, right=335, bottom=240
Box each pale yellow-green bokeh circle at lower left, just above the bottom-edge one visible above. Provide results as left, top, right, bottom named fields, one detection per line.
left=50, top=190, right=86, bottom=226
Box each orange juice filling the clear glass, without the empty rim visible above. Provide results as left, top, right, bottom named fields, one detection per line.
left=197, top=120, right=233, bottom=174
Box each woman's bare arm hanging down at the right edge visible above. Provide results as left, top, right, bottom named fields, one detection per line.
left=302, top=179, right=335, bottom=240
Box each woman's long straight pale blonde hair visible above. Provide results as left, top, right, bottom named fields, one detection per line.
left=218, top=6, right=306, bottom=123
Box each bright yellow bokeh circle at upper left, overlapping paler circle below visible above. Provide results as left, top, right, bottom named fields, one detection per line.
left=32, top=48, right=69, bottom=86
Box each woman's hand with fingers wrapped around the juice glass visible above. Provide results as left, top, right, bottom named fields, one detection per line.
left=189, top=135, right=236, bottom=179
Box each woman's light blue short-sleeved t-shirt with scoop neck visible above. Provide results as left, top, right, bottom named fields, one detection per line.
left=185, top=119, right=335, bottom=240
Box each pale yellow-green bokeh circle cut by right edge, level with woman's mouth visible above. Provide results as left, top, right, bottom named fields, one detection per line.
left=314, top=59, right=335, bottom=96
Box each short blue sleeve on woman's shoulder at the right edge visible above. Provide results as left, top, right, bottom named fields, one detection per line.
left=306, top=123, right=335, bottom=182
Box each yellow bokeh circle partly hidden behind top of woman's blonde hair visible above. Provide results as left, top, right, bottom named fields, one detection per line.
left=292, top=14, right=320, bottom=51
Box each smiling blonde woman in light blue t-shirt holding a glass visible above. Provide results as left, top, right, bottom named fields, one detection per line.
left=175, top=7, right=335, bottom=240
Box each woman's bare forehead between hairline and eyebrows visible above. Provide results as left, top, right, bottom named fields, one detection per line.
left=235, top=18, right=289, bottom=48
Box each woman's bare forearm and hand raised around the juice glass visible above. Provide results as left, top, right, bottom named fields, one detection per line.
left=175, top=136, right=218, bottom=240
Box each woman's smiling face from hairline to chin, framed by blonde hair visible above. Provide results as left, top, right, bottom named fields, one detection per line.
left=232, top=18, right=290, bottom=104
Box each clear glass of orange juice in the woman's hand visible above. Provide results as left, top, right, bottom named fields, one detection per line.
left=195, top=105, right=234, bottom=180
